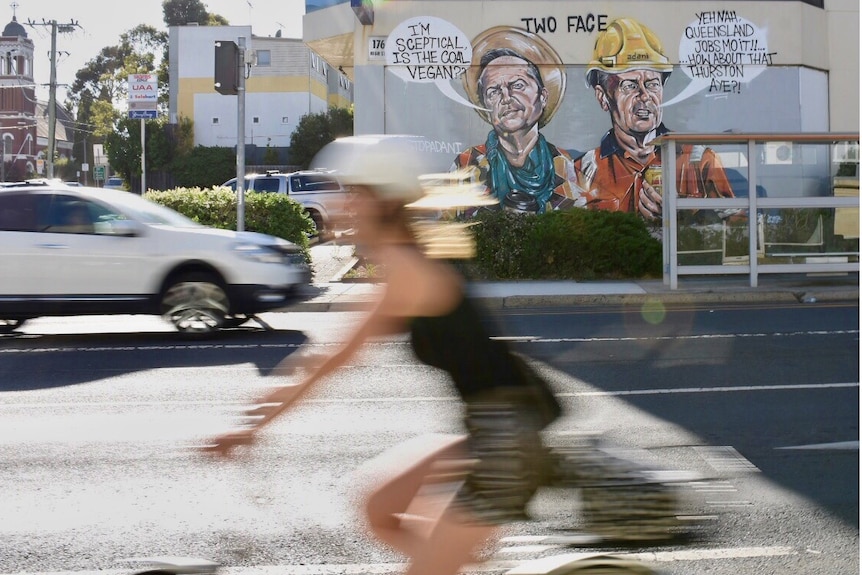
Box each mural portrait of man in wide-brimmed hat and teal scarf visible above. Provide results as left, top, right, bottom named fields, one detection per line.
left=452, top=26, right=580, bottom=213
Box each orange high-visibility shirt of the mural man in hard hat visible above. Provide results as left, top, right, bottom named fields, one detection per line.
left=575, top=125, right=734, bottom=216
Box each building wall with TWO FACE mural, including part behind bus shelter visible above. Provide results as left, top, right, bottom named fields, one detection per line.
left=303, top=0, right=860, bottom=281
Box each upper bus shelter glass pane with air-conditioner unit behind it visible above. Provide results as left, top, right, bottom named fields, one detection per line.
left=756, top=141, right=833, bottom=198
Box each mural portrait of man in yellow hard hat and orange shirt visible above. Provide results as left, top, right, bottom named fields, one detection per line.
left=575, top=18, right=733, bottom=220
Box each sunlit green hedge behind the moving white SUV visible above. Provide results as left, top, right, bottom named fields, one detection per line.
left=144, top=187, right=314, bottom=261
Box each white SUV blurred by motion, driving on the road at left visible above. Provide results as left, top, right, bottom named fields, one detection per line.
left=0, top=181, right=311, bottom=334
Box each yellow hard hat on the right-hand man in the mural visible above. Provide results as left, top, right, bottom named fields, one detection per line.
left=587, top=18, right=673, bottom=86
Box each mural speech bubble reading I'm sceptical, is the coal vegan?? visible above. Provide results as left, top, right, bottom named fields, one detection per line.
left=385, top=16, right=484, bottom=110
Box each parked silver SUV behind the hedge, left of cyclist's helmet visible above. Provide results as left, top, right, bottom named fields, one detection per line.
left=222, top=170, right=351, bottom=233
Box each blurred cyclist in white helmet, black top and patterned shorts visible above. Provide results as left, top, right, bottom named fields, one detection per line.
left=206, top=136, right=560, bottom=575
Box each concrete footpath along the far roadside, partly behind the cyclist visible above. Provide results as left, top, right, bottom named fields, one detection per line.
left=288, top=242, right=859, bottom=311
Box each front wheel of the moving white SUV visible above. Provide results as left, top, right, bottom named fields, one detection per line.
left=162, top=274, right=230, bottom=335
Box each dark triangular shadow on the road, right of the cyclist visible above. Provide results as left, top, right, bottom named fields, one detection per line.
left=496, top=307, right=859, bottom=529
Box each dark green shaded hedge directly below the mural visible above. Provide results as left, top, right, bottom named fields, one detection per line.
left=471, top=209, right=662, bottom=280
